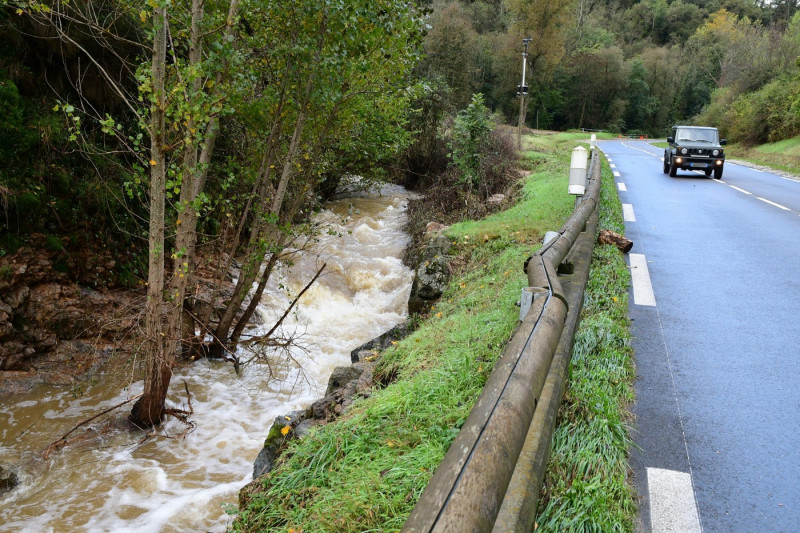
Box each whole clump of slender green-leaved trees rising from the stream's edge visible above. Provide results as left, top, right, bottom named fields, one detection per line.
left=7, top=0, right=421, bottom=427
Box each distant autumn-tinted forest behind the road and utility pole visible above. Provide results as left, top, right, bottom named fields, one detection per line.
left=419, top=0, right=800, bottom=139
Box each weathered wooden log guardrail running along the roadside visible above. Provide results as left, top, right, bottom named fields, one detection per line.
left=403, top=150, right=600, bottom=533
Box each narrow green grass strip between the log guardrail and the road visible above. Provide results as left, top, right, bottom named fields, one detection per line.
left=536, top=154, right=636, bottom=532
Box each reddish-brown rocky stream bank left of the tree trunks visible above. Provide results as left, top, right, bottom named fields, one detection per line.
left=0, top=235, right=136, bottom=395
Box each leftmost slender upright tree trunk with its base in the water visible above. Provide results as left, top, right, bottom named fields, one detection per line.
left=130, top=5, right=172, bottom=427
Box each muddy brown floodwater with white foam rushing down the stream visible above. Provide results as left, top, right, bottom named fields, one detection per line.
left=0, top=182, right=411, bottom=533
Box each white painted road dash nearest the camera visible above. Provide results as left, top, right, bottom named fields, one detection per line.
left=647, top=468, right=702, bottom=533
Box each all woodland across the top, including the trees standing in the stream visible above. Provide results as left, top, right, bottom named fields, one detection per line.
left=0, top=0, right=800, bottom=425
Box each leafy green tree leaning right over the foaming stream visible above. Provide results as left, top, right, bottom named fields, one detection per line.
left=201, top=0, right=422, bottom=368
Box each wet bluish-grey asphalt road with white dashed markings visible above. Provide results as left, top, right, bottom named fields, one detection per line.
left=598, top=141, right=800, bottom=532
